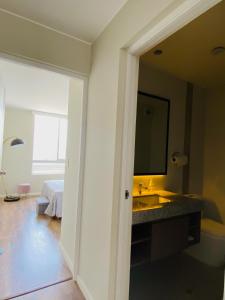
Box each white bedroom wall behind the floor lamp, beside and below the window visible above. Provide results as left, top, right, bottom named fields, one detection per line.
left=0, top=107, right=64, bottom=194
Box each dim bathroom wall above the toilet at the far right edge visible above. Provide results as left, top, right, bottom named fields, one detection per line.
left=203, top=87, right=225, bottom=223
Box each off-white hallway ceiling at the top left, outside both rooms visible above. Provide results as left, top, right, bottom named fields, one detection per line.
left=0, top=0, right=127, bottom=43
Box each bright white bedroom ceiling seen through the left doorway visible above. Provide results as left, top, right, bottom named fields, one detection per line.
left=0, top=59, right=69, bottom=114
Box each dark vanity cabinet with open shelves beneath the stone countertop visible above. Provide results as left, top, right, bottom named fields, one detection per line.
left=131, top=212, right=201, bottom=266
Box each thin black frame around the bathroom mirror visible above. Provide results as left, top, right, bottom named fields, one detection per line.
left=134, top=90, right=170, bottom=176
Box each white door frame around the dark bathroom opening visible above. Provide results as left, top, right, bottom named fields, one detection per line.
left=115, top=0, right=221, bottom=300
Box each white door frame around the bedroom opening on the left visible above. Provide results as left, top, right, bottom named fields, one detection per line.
left=0, top=52, right=88, bottom=281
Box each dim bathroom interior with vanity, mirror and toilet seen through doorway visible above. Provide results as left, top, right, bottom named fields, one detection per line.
left=130, top=1, right=225, bottom=300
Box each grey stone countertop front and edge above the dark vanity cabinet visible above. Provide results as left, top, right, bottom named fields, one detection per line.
left=132, top=195, right=203, bottom=225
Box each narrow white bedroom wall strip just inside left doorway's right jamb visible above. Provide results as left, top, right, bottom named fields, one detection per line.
left=61, top=79, right=84, bottom=273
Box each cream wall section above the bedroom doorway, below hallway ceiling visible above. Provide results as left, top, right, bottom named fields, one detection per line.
left=0, top=11, right=91, bottom=74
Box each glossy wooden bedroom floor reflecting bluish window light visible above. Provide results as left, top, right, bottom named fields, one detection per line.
left=0, top=198, right=72, bottom=300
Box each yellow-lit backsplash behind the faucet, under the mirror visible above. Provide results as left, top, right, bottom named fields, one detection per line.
left=133, top=175, right=166, bottom=196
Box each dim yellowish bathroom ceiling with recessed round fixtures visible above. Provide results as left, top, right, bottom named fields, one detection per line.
left=141, top=0, right=225, bottom=88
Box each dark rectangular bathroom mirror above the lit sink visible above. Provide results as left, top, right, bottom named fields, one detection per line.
left=134, top=91, right=170, bottom=175
